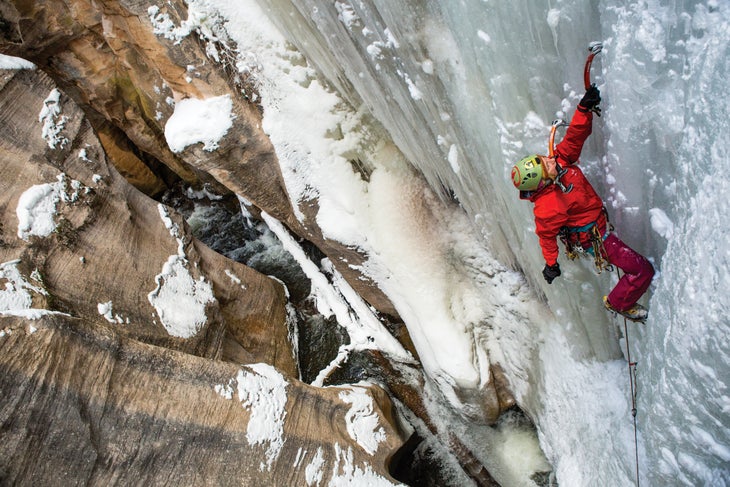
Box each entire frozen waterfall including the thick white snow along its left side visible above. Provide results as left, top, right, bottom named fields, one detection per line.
left=200, top=0, right=730, bottom=486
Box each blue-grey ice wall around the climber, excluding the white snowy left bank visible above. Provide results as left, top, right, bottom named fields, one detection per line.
left=246, top=0, right=730, bottom=485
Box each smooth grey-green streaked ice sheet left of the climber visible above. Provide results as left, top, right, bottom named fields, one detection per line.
left=262, top=0, right=618, bottom=359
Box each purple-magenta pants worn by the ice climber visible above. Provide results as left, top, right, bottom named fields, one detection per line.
left=603, top=233, right=654, bottom=311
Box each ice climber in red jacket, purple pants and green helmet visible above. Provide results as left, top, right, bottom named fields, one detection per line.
left=512, top=86, right=654, bottom=321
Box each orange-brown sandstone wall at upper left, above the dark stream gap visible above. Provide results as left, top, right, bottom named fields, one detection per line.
left=0, top=0, right=397, bottom=316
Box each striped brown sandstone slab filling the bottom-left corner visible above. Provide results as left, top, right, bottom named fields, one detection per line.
left=0, top=315, right=400, bottom=486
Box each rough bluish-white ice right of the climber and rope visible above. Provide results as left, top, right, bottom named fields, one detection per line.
left=600, top=1, right=730, bottom=485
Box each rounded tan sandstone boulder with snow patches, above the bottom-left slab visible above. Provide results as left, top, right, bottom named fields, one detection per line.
left=0, top=71, right=296, bottom=373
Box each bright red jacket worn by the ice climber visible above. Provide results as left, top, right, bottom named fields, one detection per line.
left=530, top=110, right=606, bottom=265
